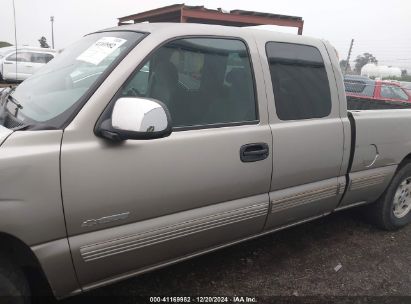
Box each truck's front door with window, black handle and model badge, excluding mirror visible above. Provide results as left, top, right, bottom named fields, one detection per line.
left=61, top=37, right=272, bottom=288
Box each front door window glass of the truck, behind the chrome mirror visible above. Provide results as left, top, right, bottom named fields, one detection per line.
left=121, top=38, right=258, bottom=127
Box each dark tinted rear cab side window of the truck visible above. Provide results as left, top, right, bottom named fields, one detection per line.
left=266, top=42, right=332, bottom=121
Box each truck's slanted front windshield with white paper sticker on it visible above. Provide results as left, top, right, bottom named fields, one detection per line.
left=7, top=31, right=143, bottom=128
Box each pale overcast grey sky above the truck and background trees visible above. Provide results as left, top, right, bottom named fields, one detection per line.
left=0, top=0, right=411, bottom=72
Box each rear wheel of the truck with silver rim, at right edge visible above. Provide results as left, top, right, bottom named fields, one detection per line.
left=369, top=163, right=411, bottom=230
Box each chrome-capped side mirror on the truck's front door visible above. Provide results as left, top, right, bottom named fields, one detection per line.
left=97, top=97, right=172, bottom=141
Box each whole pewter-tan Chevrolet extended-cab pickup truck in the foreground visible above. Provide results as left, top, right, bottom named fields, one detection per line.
left=0, top=23, right=411, bottom=302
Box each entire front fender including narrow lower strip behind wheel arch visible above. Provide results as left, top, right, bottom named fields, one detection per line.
left=0, top=127, right=79, bottom=297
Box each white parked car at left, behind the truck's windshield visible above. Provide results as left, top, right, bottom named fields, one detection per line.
left=0, top=47, right=56, bottom=81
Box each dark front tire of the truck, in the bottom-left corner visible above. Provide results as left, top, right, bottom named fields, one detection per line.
left=0, top=256, right=30, bottom=304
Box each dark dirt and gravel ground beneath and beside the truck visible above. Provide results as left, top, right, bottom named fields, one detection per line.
left=40, top=209, right=411, bottom=304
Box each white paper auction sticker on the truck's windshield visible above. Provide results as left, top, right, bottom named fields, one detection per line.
left=76, top=37, right=127, bottom=65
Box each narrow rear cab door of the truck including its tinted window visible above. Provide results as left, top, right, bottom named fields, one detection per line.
left=258, top=36, right=345, bottom=229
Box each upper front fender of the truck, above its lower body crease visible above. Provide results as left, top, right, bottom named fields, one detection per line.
left=0, top=127, right=67, bottom=246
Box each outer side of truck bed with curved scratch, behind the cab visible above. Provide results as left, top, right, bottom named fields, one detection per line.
left=339, top=109, right=411, bottom=208
